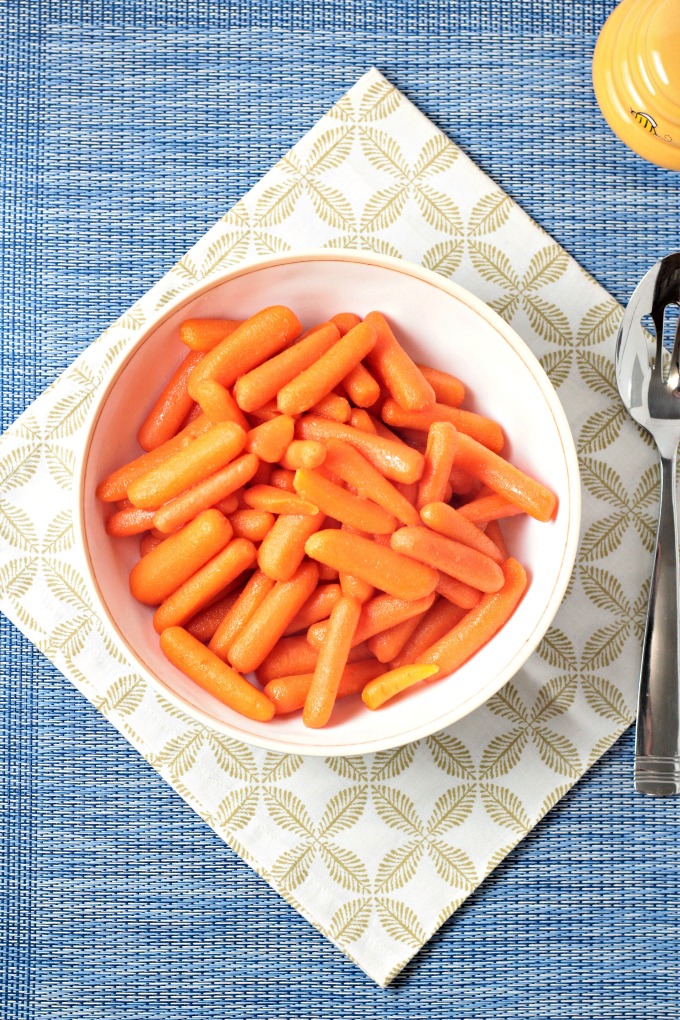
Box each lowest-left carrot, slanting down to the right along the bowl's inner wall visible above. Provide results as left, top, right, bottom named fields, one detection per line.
left=160, top=627, right=274, bottom=722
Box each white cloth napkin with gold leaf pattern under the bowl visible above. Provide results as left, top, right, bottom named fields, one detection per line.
left=0, top=70, right=657, bottom=985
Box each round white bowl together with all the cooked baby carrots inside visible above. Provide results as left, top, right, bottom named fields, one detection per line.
left=80, top=250, right=580, bottom=756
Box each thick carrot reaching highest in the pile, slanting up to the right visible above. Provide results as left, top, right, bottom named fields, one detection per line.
left=189, top=305, right=301, bottom=397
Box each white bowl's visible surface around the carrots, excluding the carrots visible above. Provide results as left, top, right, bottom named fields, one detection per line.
left=80, top=250, right=580, bottom=755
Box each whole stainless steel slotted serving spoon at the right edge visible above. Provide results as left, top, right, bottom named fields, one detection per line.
left=616, top=252, right=680, bottom=797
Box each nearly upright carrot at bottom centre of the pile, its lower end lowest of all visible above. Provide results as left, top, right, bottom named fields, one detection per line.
left=302, top=597, right=361, bottom=729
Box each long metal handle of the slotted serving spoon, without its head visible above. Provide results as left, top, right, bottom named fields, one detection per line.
left=635, top=449, right=680, bottom=797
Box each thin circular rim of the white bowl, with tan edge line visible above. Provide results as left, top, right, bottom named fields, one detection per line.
left=73, top=248, right=581, bottom=757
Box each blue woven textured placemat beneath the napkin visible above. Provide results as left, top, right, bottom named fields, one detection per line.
left=0, top=0, right=680, bottom=1020
